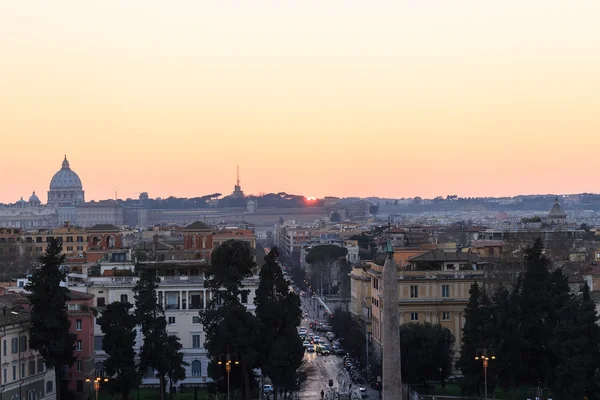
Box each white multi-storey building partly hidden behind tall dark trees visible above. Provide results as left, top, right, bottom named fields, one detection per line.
left=84, top=251, right=259, bottom=385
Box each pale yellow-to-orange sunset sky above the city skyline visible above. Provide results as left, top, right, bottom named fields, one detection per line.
left=0, top=0, right=600, bottom=202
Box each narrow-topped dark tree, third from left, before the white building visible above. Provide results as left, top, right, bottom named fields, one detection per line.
left=133, top=269, right=185, bottom=399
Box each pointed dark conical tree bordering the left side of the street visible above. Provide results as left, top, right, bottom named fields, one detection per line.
left=254, top=248, right=304, bottom=392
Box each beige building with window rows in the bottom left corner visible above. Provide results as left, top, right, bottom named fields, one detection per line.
left=0, top=293, right=56, bottom=400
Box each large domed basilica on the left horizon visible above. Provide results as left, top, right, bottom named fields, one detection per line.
left=0, top=156, right=85, bottom=229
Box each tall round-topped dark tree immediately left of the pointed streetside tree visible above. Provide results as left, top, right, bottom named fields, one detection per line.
left=199, top=240, right=261, bottom=399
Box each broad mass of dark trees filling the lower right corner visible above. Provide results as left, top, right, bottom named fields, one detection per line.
left=456, top=238, right=600, bottom=399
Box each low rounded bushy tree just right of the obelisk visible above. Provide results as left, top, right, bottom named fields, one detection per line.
left=400, top=322, right=454, bottom=385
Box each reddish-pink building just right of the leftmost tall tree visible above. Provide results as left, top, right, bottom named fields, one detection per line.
left=65, top=290, right=96, bottom=399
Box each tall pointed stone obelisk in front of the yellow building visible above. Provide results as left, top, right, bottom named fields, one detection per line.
left=381, top=240, right=402, bottom=400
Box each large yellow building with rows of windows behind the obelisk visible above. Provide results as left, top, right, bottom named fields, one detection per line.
left=350, top=250, right=485, bottom=356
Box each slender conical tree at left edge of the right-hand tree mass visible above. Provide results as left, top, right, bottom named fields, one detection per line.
left=456, top=282, right=483, bottom=394
